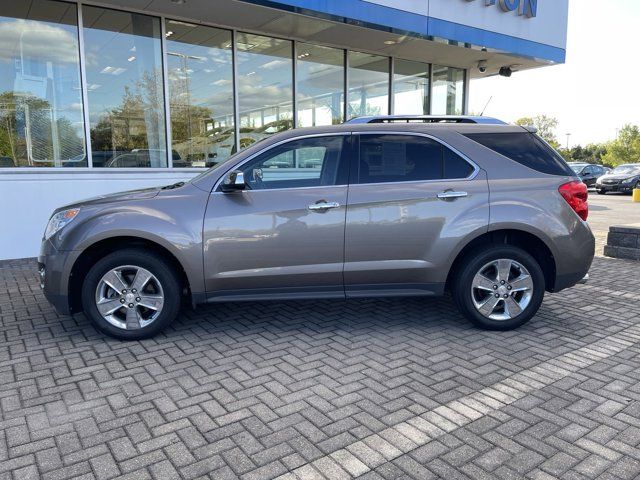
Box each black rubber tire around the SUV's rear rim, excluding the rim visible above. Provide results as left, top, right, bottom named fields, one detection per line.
left=452, top=245, right=545, bottom=331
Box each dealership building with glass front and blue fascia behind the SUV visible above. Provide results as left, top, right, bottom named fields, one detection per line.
left=0, top=0, right=568, bottom=260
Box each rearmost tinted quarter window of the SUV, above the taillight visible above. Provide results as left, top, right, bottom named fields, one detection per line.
left=466, top=132, right=575, bottom=176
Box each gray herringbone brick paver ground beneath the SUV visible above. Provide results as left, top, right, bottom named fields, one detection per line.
left=0, top=258, right=640, bottom=480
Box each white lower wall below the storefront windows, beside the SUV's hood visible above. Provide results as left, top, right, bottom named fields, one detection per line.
left=0, top=168, right=202, bottom=260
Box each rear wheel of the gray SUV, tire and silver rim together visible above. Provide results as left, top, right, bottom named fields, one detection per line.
left=453, top=246, right=545, bottom=330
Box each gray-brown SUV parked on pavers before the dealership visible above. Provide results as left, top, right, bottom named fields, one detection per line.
left=39, top=121, right=594, bottom=339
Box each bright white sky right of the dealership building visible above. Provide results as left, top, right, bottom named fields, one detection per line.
left=469, top=0, right=640, bottom=146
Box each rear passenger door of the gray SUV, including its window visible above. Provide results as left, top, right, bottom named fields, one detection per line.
left=344, top=133, right=489, bottom=297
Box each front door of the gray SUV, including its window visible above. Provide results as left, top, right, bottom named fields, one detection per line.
left=204, top=134, right=350, bottom=301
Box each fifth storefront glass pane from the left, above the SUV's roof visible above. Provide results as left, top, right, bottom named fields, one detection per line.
left=296, top=43, right=344, bottom=127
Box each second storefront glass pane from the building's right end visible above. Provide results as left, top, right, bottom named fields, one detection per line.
left=393, top=59, right=429, bottom=115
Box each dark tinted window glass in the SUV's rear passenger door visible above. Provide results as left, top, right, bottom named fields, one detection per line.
left=359, top=134, right=473, bottom=183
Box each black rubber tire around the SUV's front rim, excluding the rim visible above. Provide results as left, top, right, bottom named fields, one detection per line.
left=82, top=248, right=181, bottom=340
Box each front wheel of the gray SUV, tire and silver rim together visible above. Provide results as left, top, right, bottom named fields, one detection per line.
left=82, top=249, right=180, bottom=340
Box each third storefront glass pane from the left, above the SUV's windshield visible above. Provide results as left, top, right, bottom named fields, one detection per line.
left=165, top=20, right=235, bottom=167
